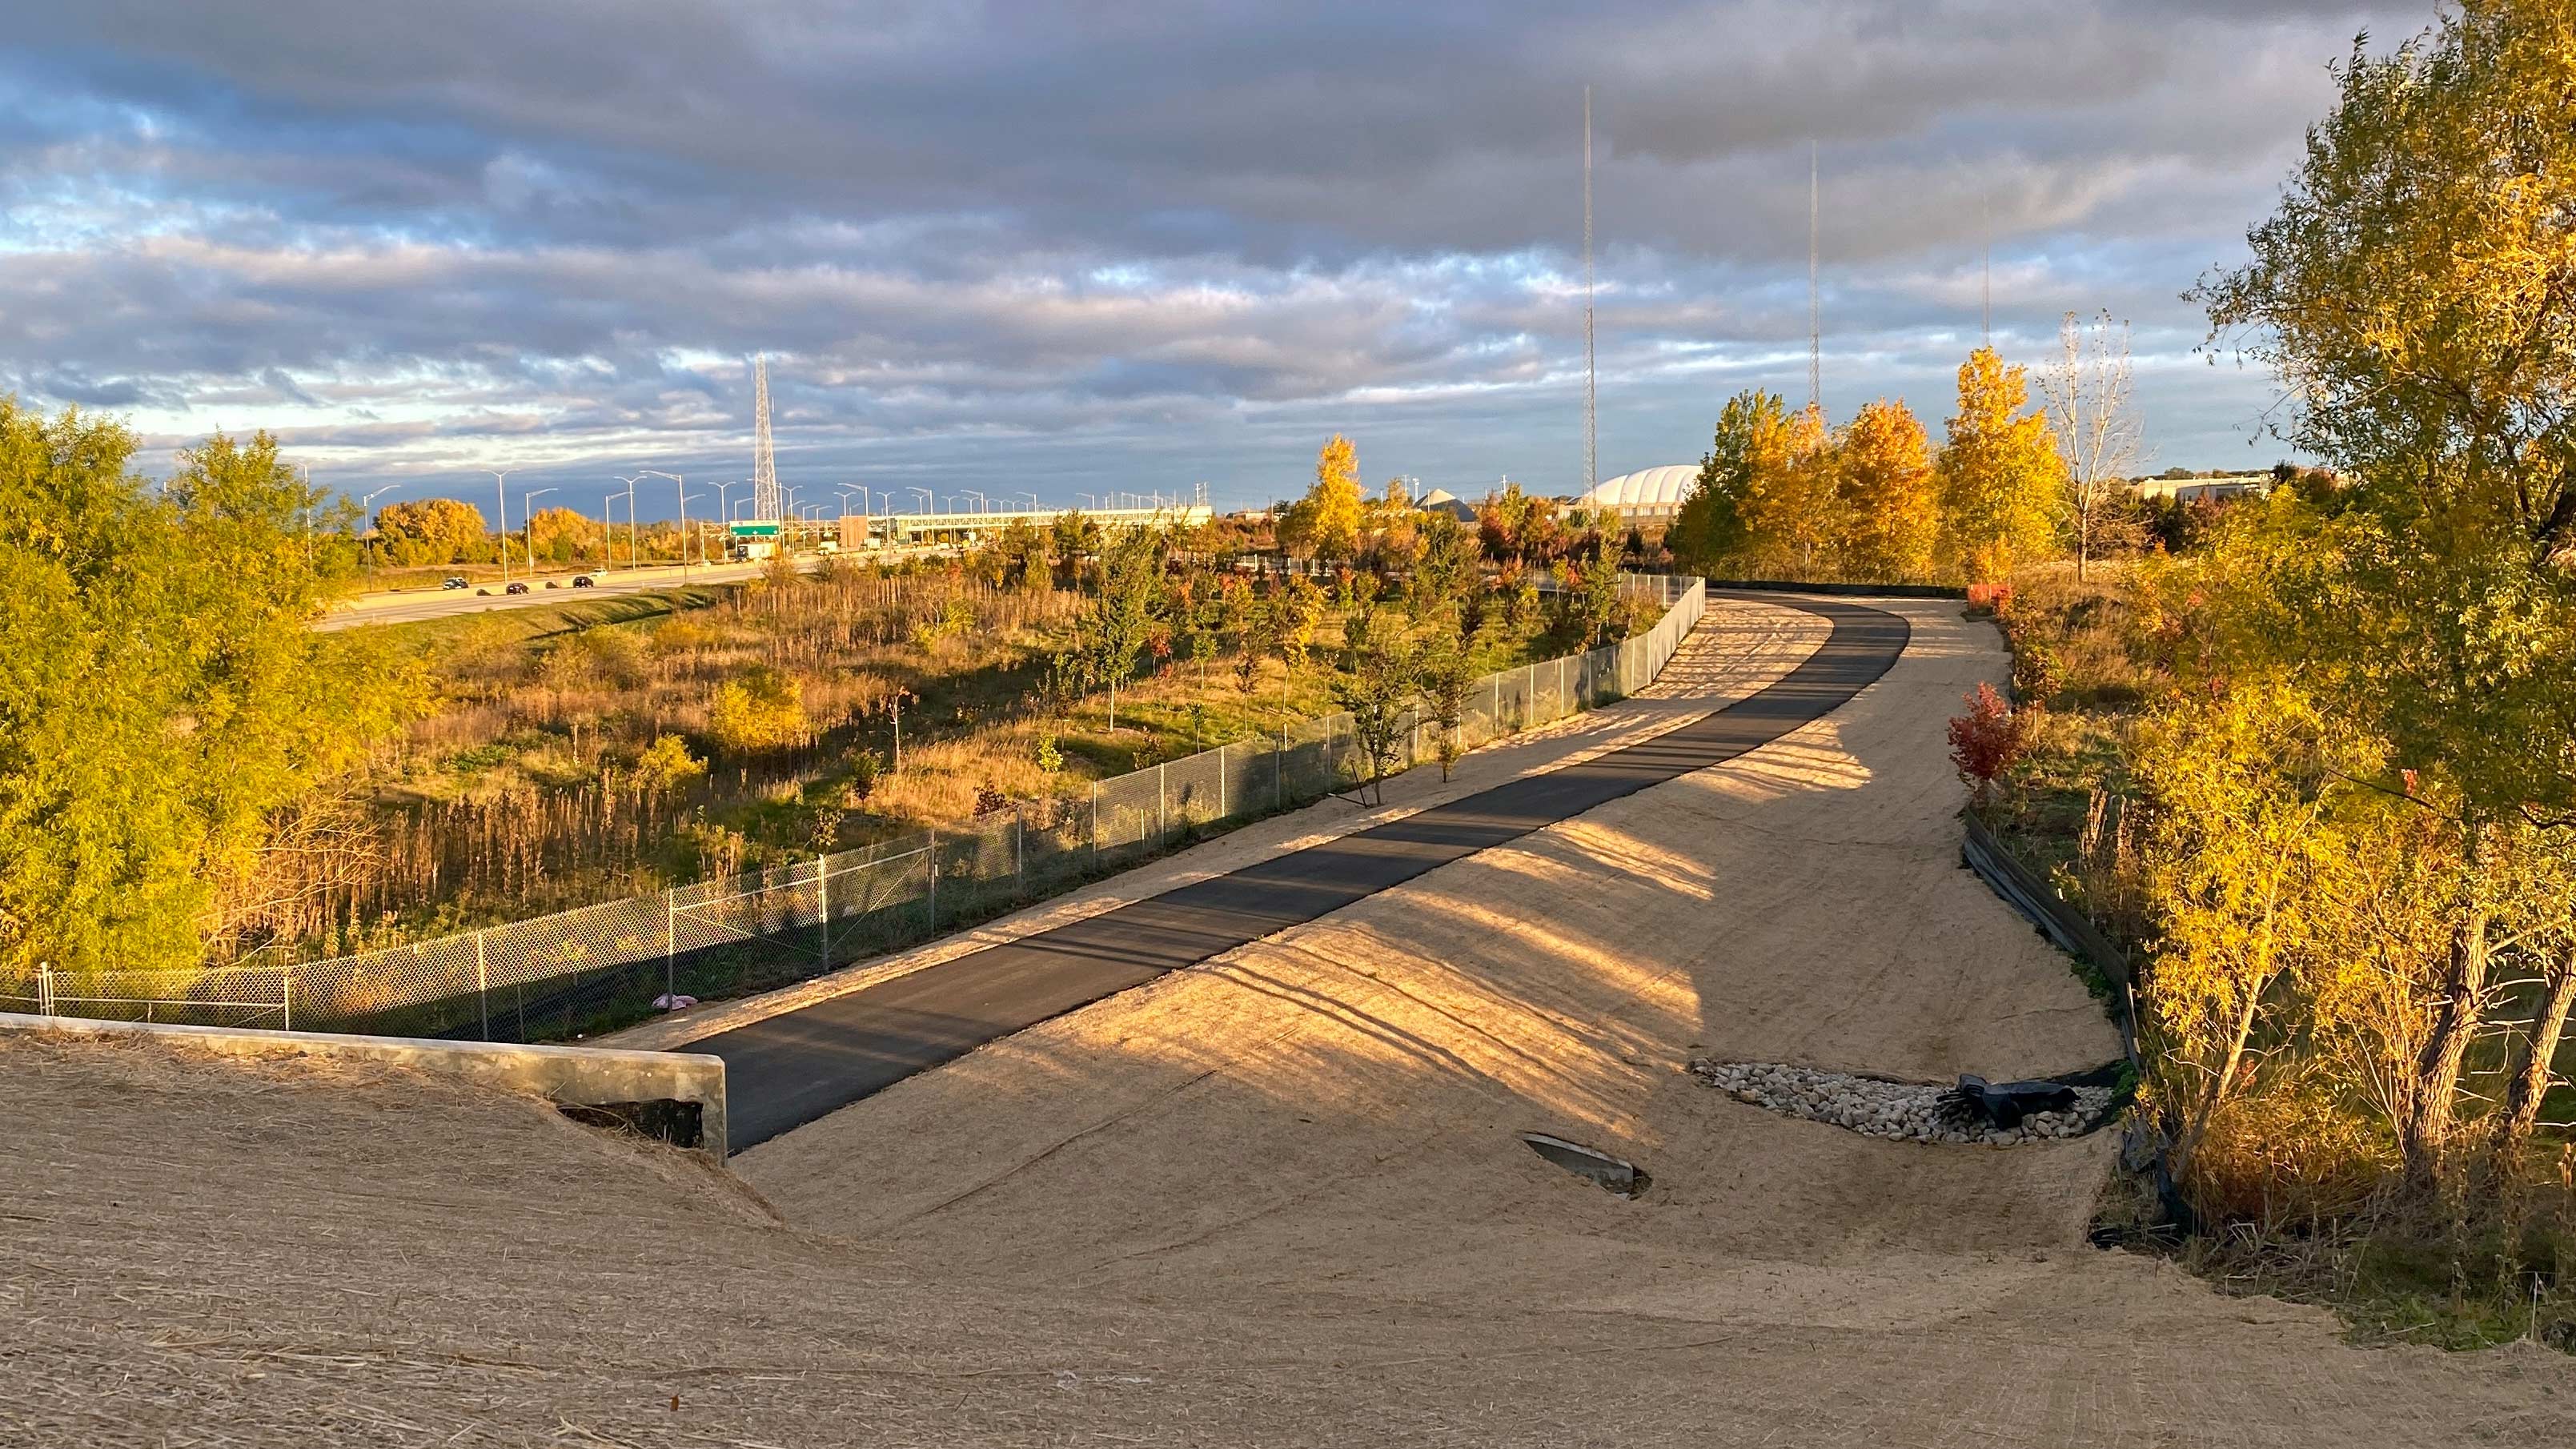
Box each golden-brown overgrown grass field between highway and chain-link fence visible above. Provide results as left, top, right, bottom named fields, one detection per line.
left=275, top=568, right=1627, bottom=957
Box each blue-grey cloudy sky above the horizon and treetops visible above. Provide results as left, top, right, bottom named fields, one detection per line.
left=0, top=0, right=2432, bottom=516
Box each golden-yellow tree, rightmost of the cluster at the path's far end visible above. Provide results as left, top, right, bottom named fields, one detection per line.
left=1935, top=348, right=2064, bottom=583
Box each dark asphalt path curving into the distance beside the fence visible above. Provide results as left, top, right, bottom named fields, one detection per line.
left=680, top=593, right=1912, bottom=1153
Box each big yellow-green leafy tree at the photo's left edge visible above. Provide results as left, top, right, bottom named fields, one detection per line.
left=0, top=397, right=425, bottom=972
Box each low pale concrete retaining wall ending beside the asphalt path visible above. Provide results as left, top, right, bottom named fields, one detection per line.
left=0, top=1010, right=724, bottom=1163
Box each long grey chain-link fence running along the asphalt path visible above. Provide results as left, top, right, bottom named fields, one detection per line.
left=14, top=575, right=1703, bottom=1042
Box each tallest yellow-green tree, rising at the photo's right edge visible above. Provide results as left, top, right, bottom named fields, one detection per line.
left=2200, top=0, right=2576, bottom=1178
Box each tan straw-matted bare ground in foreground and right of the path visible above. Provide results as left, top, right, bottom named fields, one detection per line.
left=0, top=592, right=2576, bottom=1447
